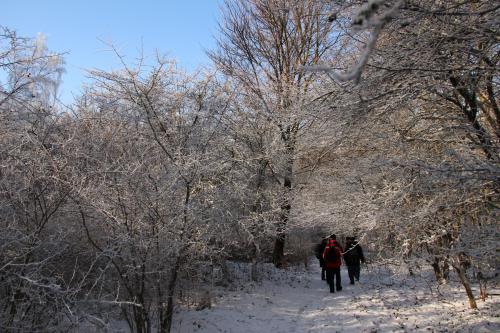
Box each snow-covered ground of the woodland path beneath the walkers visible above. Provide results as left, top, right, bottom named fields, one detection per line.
left=172, top=263, right=500, bottom=333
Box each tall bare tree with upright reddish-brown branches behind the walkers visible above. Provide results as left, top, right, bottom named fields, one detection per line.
left=210, top=0, right=333, bottom=266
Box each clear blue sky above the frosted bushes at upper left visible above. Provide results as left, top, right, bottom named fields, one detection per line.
left=0, top=0, right=223, bottom=103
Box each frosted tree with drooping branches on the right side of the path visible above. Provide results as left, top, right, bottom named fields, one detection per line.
left=310, top=1, right=499, bottom=307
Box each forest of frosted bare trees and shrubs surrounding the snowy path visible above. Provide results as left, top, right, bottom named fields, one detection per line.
left=0, top=0, right=500, bottom=332
